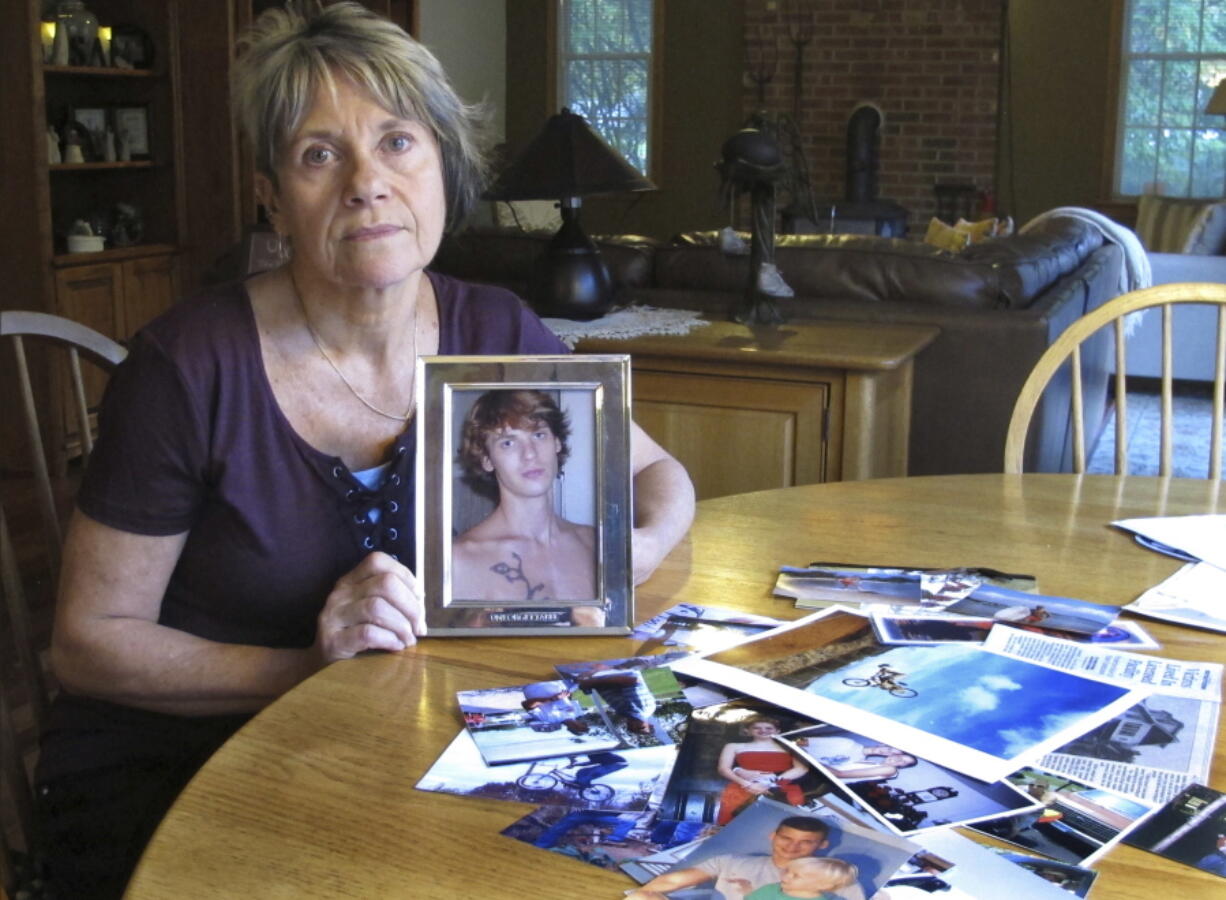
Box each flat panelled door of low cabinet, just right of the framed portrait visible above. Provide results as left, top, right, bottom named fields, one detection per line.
left=634, top=370, right=830, bottom=499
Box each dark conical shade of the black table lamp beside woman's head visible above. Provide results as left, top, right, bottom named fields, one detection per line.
left=485, top=109, right=656, bottom=200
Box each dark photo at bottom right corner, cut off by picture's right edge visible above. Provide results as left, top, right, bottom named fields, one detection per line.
left=1124, top=785, right=1226, bottom=878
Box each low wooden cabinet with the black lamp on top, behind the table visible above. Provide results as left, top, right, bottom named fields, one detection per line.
left=576, top=321, right=938, bottom=499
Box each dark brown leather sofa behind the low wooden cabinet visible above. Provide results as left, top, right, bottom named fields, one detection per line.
left=434, top=217, right=1123, bottom=475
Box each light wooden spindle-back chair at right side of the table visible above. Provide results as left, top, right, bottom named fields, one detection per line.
left=1004, top=283, right=1226, bottom=479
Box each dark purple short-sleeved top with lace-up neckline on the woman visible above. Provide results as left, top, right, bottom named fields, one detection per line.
left=44, top=272, right=569, bottom=784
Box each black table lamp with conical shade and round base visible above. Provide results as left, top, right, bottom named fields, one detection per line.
left=485, top=107, right=656, bottom=320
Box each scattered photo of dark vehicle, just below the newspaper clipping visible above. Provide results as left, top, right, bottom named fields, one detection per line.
left=975, top=766, right=1152, bottom=866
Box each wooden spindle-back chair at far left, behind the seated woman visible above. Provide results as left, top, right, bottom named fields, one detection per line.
left=0, top=311, right=128, bottom=894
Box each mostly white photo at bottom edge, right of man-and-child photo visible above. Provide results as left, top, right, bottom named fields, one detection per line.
left=886, top=829, right=1068, bottom=900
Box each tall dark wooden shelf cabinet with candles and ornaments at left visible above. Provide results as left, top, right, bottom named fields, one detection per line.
left=0, top=0, right=186, bottom=467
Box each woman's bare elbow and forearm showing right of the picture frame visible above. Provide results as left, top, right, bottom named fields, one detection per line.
left=630, top=424, right=694, bottom=585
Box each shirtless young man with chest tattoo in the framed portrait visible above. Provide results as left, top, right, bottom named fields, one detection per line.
left=451, top=390, right=597, bottom=613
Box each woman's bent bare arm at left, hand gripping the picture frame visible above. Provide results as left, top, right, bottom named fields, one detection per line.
left=51, top=513, right=419, bottom=715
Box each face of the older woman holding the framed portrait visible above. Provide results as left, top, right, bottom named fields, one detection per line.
left=259, top=77, right=446, bottom=288
